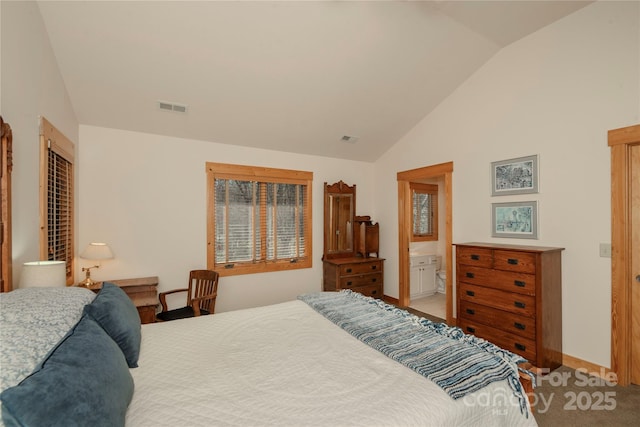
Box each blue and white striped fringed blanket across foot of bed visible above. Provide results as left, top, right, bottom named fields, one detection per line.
left=298, top=290, right=528, bottom=416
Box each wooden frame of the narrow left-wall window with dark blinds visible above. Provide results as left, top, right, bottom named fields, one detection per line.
left=40, top=117, right=75, bottom=286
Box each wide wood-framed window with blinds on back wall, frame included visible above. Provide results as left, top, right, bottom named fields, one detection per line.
left=207, top=163, right=313, bottom=276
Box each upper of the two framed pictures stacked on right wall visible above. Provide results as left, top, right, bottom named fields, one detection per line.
left=491, top=155, right=538, bottom=196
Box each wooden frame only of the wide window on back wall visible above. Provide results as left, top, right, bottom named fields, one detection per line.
left=206, top=162, right=313, bottom=276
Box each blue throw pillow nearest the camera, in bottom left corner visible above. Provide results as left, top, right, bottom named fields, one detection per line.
left=0, top=316, right=133, bottom=426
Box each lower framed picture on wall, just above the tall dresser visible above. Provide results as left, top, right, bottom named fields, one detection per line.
left=491, top=201, right=538, bottom=239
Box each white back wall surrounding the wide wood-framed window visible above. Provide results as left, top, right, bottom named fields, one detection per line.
left=77, top=125, right=375, bottom=312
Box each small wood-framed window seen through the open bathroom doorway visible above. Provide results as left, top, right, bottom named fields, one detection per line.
left=409, top=182, right=438, bottom=242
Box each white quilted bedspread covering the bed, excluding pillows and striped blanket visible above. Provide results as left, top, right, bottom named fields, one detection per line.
left=127, top=301, right=535, bottom=427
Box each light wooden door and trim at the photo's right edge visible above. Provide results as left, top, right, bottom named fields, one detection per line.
left=608, top=125, right=640, bottom=385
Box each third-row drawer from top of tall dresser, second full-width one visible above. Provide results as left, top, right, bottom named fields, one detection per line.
left=459, top=283, right=536, bottom=317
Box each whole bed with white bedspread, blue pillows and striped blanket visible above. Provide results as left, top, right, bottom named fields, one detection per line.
left=0, top=286, right=536, bottom=426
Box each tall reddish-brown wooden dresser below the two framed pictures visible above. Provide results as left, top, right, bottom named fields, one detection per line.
left=456, top=243, right=563, bottom=369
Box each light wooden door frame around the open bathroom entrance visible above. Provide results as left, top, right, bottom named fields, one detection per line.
left=397, top=162, right=455, bottom=325
